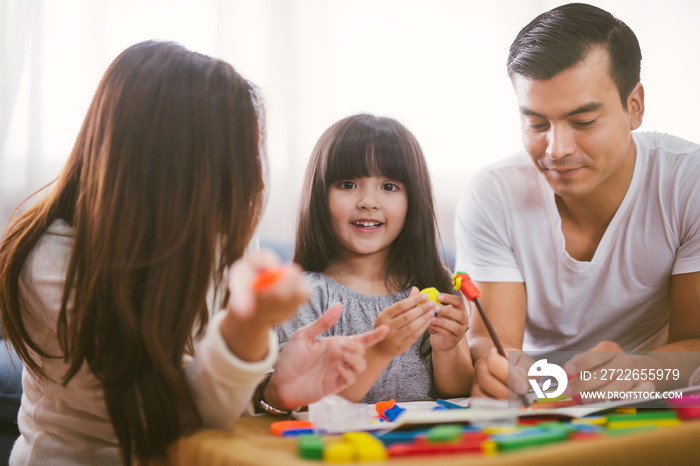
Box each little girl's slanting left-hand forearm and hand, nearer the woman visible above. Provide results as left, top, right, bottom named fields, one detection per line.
left=340, top=288, right=435, bottom=403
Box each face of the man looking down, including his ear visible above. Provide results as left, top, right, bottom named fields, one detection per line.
left=513, top=48, right=644, bottom=197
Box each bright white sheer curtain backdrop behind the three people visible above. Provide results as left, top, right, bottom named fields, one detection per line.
left=0, top=0, right=700, bottom=253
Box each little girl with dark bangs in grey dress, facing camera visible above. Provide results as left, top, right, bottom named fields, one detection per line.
left=277, top=115, right=473, bottom=403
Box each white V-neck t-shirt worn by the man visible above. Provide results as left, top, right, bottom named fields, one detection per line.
left=455, top=133, right=700, bottom=351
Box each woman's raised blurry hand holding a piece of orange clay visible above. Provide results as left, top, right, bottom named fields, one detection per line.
left=221, top=251, right=309, bottom=361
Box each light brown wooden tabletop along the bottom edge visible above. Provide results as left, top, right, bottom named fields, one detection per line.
left=151, top=416, right=700, bottom=466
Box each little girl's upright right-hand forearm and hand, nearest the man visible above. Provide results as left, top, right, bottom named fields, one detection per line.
left=429, top=293, right=474, bottom=398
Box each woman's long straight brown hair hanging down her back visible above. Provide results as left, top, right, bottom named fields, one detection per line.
left=0, top=41, right=263, bottom=464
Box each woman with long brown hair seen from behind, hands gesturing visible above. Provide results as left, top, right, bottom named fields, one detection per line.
left=0, top=42, right=382, bottom=465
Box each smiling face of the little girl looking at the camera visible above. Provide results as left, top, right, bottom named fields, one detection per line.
left=328, top=176, right=408, bottom=255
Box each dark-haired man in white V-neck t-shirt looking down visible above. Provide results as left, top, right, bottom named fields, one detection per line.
left=456, top=4, right=700, bottom=398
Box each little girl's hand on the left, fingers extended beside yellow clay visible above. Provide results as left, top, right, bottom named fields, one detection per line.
left=373, top=287, right=437, bottom=359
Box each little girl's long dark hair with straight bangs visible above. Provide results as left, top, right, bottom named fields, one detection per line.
left=294, top=114, right=454, bottom=293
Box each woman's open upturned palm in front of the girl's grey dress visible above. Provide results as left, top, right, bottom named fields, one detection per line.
left=263, top=303, right=389, bottom=410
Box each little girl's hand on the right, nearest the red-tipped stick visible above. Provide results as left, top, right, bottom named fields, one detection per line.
left=428, top=293, right=469, bottom=352
